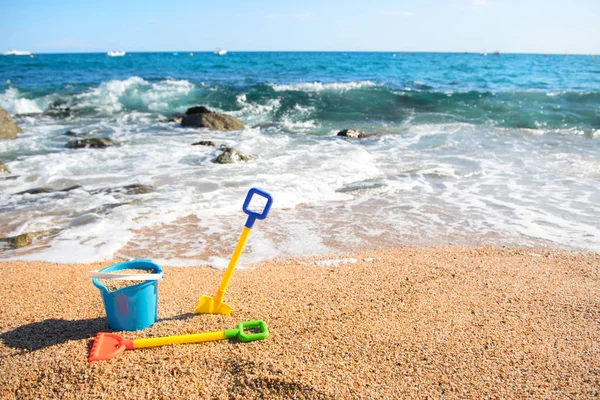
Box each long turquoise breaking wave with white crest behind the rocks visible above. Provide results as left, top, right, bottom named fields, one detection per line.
left=0, top=76, right=600, bottom=137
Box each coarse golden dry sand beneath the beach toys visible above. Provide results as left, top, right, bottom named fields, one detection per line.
left=0, top=247, right=600, bottom=399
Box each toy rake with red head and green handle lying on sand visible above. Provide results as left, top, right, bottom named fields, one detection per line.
left=88, top=321, right=269, bottom=362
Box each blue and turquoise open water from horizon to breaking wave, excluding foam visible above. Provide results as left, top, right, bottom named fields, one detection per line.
left=0, top=53, right=600, bottom=131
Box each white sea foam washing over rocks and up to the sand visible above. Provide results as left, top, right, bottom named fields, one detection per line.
left=0, top=99, right=600, bottom=268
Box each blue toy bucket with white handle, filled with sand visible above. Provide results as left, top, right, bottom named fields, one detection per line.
left=90, top=260, right=164, bottom=331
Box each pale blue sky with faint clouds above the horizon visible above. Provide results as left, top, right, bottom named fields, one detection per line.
left=0, top=0, right=600, bottom=54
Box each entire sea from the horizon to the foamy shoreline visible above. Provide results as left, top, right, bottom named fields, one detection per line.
left=0, top=52, right=600, bottom=268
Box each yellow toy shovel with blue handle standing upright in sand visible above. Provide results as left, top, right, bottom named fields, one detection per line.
left=194, top=188, right=273, bottom=315
